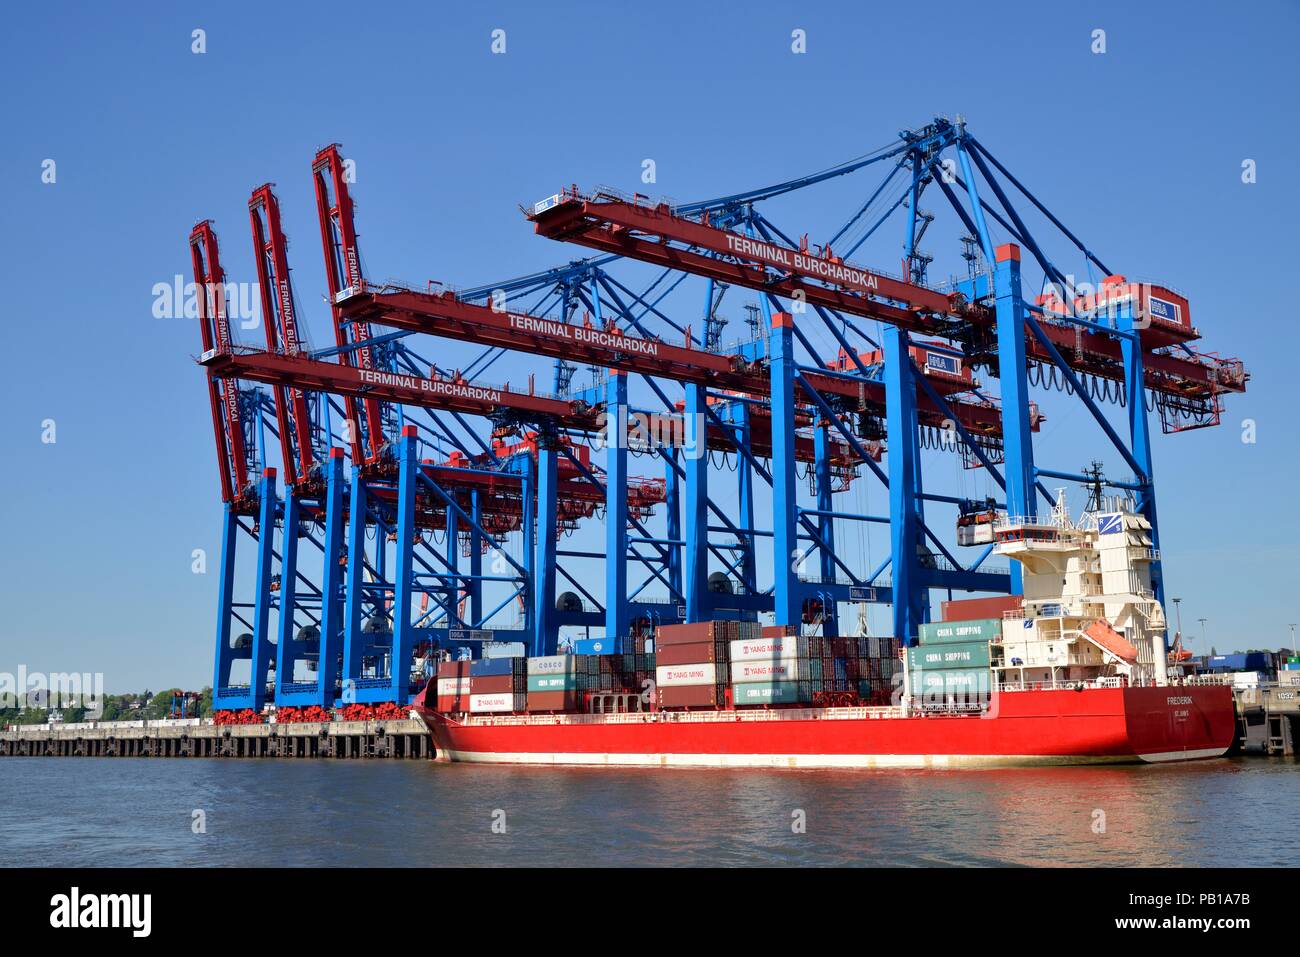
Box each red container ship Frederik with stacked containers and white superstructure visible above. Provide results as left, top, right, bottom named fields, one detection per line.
left=415, top=494, right=1235, bottom=768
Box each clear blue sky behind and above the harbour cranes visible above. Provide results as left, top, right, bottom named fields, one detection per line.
left=0, top=0, right=1300, bottom=690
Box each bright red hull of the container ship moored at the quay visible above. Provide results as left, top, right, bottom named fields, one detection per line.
left=417, top=687, right=1236, bottom=767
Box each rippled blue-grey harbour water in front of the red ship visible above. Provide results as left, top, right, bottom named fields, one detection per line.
left=0, top=758, right=1300, bottom=866
